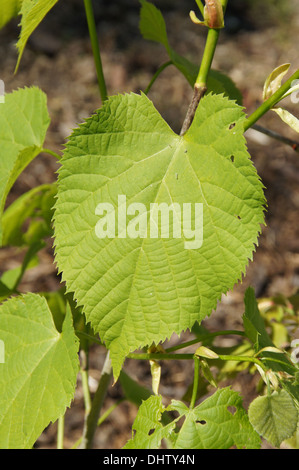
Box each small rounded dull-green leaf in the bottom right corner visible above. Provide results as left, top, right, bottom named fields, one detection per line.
left=248, top=390, right=298, bottom=447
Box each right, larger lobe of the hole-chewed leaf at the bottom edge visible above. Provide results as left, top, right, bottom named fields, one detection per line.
left=171, top=388, right=260, bottom=449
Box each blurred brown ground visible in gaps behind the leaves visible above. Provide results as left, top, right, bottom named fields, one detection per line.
left=0, top=0, right=299, bottom=449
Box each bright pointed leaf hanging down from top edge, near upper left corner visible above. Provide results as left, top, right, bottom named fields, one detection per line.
left=16, top=0, right=58, bottom=70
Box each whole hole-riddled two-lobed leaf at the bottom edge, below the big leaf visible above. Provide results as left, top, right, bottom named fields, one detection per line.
left=125, top=388, right=260, bottom=449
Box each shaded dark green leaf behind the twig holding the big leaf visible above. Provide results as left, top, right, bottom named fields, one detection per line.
left=139, top=0, right=242, bottom=105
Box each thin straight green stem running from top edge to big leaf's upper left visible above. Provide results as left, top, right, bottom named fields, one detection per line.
left=84, top=0, right=108, bottom=102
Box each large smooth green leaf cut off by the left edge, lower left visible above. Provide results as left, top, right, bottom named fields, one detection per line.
left=0, top=294, right=78, bottom=449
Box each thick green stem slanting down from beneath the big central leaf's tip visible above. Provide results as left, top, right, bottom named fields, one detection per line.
left=80, top=353, right=112, bottom=449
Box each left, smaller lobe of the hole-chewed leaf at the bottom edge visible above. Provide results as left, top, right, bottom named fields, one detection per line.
left=124, top=395, right=175, bottom=449
